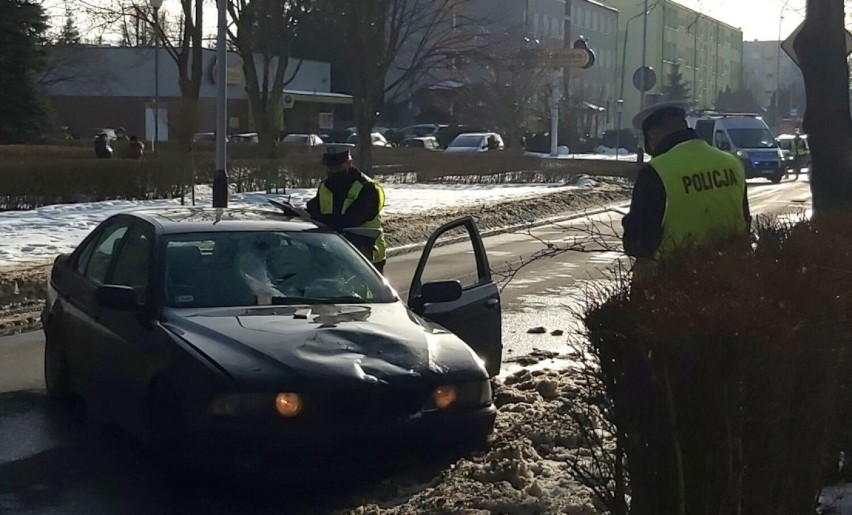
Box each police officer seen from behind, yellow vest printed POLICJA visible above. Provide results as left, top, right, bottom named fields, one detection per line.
left=622, top=102, right=751, bottom=278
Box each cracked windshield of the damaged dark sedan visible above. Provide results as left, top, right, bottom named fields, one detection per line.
left=163, top=231, right=396, bottom=308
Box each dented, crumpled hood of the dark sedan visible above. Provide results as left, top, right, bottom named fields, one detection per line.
left=165, top=302, right=485, bottom=383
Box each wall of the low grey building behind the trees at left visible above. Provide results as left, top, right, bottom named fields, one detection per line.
left=41, top=46, right=331, bottom=141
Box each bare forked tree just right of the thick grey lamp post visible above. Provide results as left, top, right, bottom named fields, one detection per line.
left=228, top=0, right=313, bottom=156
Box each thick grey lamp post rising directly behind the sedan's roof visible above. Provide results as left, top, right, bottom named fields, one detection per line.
left=213, top=0, right=228, bottom=207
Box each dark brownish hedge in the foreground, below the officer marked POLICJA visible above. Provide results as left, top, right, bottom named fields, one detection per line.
left=586, top=220, right=852, bottom=514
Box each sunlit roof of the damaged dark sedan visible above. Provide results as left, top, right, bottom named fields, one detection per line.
left=128, top=206, right=321, bottom=234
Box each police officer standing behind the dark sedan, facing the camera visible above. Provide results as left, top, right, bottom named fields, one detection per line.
left=307, top=143, right=386, bottom=272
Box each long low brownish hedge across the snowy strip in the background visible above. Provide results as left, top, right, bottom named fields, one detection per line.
left=0, top=142, right=635, bottom=210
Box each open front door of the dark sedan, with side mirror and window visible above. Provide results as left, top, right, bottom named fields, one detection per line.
left=408, top=217, right=503, bottom=377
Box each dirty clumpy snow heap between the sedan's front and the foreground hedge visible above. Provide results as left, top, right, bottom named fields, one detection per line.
left=340, top=363, right=612, bottom=515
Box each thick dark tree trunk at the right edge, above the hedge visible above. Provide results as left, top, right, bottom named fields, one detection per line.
left=796, top=0, right=852, bottom=215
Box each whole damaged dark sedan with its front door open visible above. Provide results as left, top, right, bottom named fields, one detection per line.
left=42, top=207, right=502, bottom=460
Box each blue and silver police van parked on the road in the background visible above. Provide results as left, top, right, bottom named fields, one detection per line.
left=688, top=112, right=787, bottom=183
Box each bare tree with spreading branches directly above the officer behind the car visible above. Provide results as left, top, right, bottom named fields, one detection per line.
left=318, top=0, right=476, bottom=171
